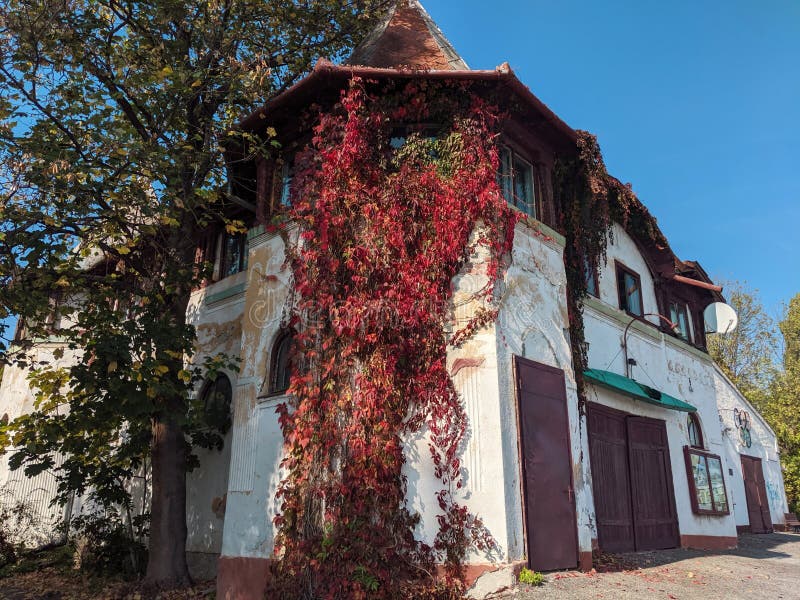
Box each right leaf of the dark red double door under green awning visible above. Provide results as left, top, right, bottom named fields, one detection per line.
left=626, top=416, right=680, bottom=550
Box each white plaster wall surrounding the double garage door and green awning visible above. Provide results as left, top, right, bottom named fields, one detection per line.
left=584, top=224, right=752, bottom=537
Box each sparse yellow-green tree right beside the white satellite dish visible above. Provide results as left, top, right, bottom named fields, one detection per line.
left=708, top=282, right=778, bottom=400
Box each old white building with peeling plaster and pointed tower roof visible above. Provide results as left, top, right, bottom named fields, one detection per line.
left=0, top=0, right=787, bottom=598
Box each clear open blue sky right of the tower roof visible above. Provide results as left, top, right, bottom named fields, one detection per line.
left=422, top=0, right=800, bottom=316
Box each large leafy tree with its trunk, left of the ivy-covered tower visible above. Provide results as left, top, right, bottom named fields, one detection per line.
left=0, top=0, right=386, bottom=587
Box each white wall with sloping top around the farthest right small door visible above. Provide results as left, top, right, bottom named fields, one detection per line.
left=713, top=368, right=789, bottom=526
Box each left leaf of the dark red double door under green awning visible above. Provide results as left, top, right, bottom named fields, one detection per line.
left=587, top=404, right=636, bottom=552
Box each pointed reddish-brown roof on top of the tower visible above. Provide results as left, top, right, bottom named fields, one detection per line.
left=345, top=0, right=469, bottom=71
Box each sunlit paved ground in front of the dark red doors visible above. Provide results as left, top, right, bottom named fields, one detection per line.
left=503, top=533, right=800, bottom=600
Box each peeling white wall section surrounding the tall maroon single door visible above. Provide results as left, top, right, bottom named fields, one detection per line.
left=496, top=221, right=596, bottom=560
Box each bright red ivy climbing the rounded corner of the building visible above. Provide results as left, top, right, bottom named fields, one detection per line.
left=272, top=79, right=516, bottom=599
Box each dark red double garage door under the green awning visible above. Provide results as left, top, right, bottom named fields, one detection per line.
left=587, top=404, right=680, bottom=552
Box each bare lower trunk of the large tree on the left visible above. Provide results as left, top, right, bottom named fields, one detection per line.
left=145, top=402, right=191, bottom=589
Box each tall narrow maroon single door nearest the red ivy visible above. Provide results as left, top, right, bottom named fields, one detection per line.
left=514, top=357, right=578, bottom=571
